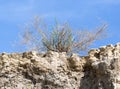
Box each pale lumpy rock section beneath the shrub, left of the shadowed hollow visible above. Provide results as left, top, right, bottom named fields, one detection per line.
left=0, top=51, right=83, bottom=89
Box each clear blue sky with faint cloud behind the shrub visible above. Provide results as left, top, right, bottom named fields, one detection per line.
left=0, top=0, right=120, bottom=52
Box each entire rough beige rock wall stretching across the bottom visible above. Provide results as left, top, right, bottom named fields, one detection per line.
left=0, top=44, right=120, bottom=89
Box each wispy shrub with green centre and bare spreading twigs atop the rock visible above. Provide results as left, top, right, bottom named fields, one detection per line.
left=19, top=17, right=107, bottom=53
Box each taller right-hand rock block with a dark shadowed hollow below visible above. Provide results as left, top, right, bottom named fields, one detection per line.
left=80, top=44, right=120, bottom=89
